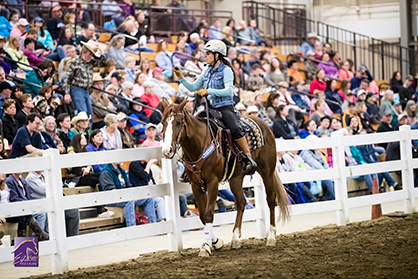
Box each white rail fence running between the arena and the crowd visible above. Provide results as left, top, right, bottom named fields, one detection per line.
left=0, top=126, right=418, bottom=274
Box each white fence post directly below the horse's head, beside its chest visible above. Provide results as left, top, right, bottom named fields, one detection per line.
left=162, top=158, right=183, bottom=251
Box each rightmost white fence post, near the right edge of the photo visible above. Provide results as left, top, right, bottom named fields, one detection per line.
left=399, top=125, right=415, bottom=213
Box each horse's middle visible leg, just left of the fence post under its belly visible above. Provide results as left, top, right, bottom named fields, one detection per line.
left=229, top=175, right=246, bottom=249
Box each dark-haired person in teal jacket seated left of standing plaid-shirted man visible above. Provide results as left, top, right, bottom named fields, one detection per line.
left=23, top=59, right=55, bottom=98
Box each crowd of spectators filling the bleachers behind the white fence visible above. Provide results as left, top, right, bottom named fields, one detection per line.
left=0, top=0, right=417, bottom=241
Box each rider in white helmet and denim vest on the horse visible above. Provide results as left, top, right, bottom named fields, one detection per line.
left=173, top=40, right=257, bottom=174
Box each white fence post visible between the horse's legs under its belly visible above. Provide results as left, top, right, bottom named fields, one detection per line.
left=254, top=174, right=270, bottom=238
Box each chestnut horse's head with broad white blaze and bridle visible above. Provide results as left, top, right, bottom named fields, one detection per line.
left=161, top=98, right=187, bottom=159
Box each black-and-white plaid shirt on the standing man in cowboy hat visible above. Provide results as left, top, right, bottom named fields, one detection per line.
left=63, top=55, right=106, bottom=94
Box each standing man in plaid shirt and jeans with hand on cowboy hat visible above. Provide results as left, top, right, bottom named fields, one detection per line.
left=63, top=40, right=106, bottom=121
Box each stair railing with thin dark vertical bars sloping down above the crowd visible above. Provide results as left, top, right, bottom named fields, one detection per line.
left=242, top=1, right=418, bottom=80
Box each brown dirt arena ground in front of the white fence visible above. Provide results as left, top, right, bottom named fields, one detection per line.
left=31, top=213, right=418, bottom=279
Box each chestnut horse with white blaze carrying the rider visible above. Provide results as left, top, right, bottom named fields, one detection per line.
left=161, top=98, right=289, bottom=257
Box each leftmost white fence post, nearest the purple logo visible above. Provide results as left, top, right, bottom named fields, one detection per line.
left=44, top=149, right=69, bottom=274
